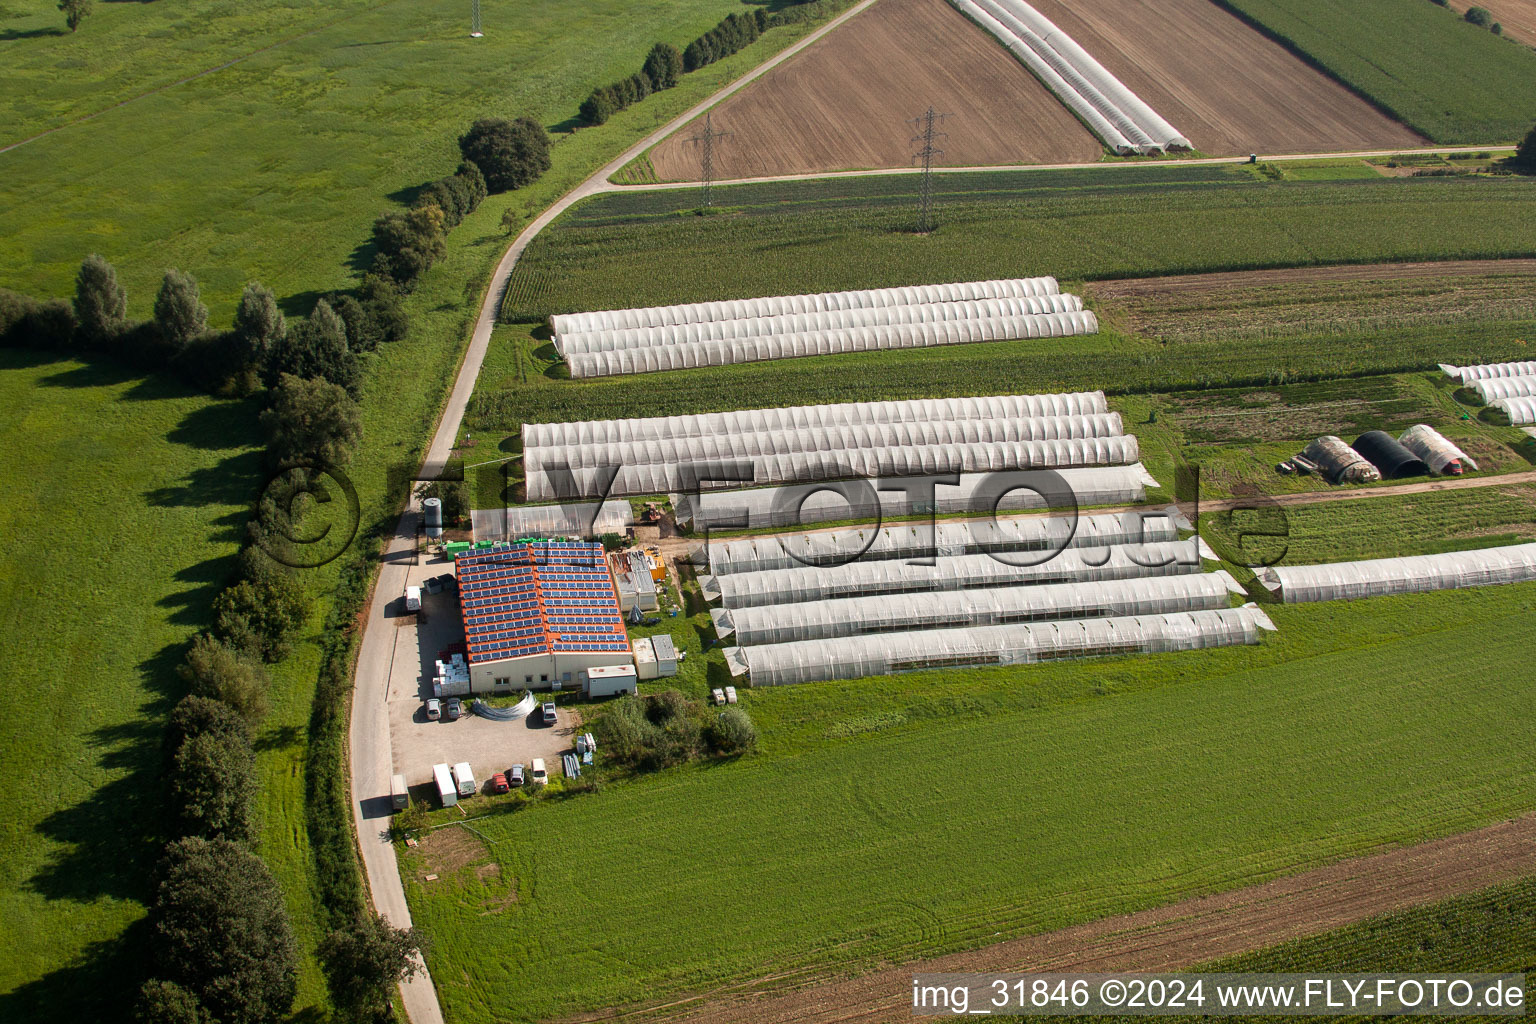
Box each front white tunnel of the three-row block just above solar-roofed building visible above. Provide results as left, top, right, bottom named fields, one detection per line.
left=525, top=436, right=1141, bottom=502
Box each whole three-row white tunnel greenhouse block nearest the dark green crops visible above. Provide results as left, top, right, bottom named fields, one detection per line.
left=550, top=278, right=1098, bottom=378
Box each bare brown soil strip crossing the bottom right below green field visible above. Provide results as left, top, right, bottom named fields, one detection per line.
left=571, top=814, right=1536, bottom=1024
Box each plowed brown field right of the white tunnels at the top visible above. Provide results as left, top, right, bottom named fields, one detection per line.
left=1029, top=0, right=1419, bottom=157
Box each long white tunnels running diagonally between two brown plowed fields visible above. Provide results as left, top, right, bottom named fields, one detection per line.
left=951, top=0, right=1192, bottom=154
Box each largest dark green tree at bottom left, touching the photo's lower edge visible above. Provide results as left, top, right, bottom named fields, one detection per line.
left=152, top=838, right=298, bottom=1024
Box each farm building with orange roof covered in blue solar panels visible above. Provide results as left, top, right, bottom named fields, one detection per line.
left=455, top=540, right=630, bottom=694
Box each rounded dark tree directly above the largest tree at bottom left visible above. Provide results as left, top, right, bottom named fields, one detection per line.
left=169, top=732, right=257, bottom=846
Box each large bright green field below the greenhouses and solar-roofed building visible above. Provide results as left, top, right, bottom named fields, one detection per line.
left=404, top=574, right=1536, bottom=1021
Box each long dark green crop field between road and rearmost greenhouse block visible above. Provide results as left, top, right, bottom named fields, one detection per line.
left=504, top=170, right=1536, bottom=321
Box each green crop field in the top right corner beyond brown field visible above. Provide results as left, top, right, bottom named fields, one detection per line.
left=1218, top=0, right=1536, bottom=146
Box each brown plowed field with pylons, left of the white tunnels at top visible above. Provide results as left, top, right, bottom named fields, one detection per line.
left=651, top=0, right=1105, bottom=181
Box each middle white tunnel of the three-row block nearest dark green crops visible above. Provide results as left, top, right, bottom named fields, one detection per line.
left=554, top=293, right=1083, bottom=356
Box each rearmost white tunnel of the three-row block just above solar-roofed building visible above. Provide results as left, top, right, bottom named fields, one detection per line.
left=522, top=391, right=1109, bottom=450
